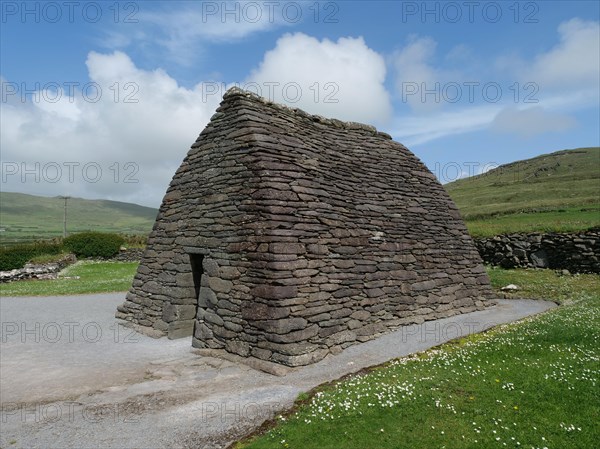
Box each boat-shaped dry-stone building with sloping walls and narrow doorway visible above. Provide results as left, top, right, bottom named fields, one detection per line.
left=117, top=89, right=493, bottom=366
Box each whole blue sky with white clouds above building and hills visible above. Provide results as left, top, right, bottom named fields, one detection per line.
left=0, top=0, right=600, bottom=207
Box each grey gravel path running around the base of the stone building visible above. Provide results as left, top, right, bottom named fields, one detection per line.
left=0, top=293, right=555, bottom=448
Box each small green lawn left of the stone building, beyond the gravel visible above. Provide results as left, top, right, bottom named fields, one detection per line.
left=0, top=261, right=138, bottom=296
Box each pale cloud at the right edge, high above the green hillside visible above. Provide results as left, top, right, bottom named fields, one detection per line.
left=522, top=18, right=600, bottom=89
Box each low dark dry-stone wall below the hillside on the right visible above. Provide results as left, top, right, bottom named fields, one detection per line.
left=475, top=229, right=600, bottom=273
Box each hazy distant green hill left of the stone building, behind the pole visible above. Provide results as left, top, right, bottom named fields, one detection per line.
left=0, top=192, right=158, bottom=244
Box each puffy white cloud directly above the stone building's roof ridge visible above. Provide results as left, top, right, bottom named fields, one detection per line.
left=245, top=33, right=392, bottom=124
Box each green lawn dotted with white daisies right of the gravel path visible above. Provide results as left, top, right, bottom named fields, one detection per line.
left=237, top=269, right=600, bottom=449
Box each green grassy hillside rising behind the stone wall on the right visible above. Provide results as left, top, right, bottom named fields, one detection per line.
left=444, top=147, right=600, bottom=236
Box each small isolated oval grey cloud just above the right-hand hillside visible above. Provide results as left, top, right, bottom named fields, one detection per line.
left=491, top=106, right=577, bottom=138
